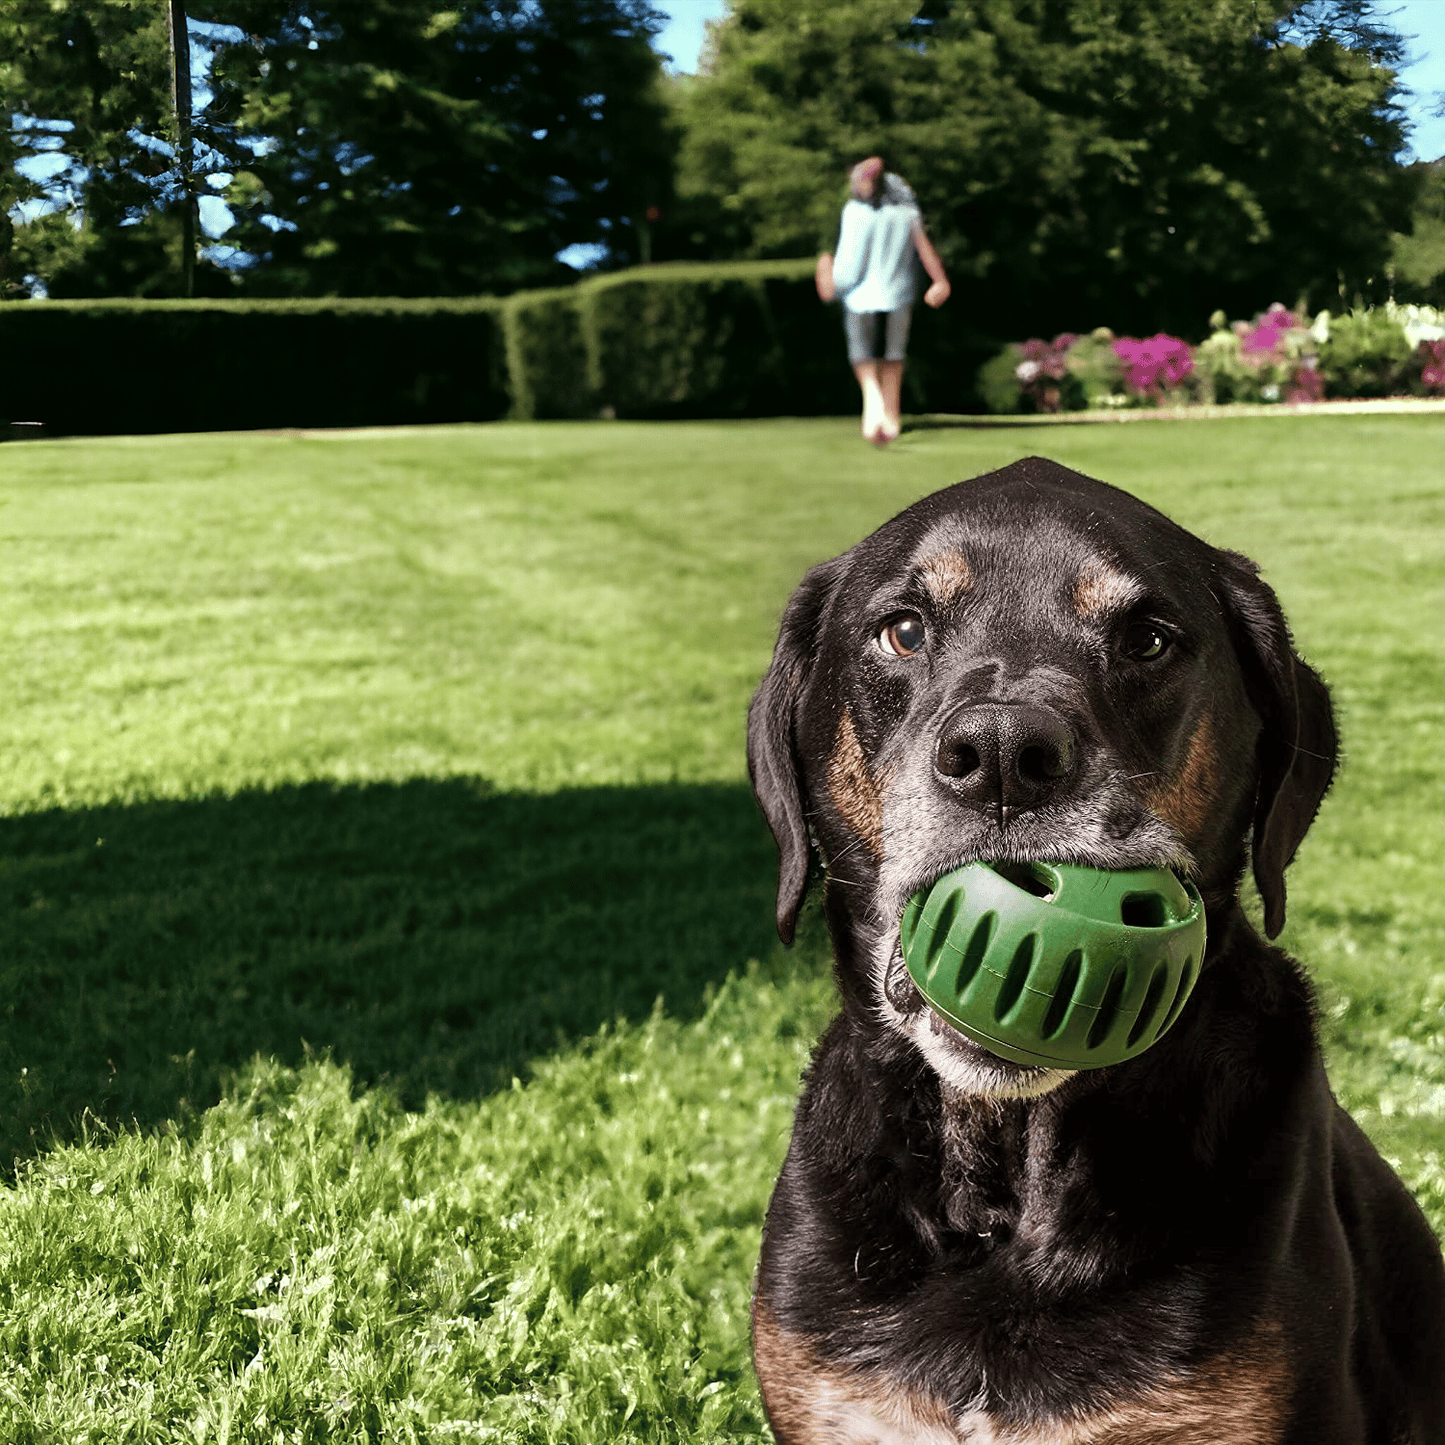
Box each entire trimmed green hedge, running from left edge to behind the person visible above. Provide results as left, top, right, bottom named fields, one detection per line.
left=0, top=260, right=998, bottom=435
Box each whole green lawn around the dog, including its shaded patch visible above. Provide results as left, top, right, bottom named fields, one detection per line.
left=0, top=416, right=1445, bottom=1442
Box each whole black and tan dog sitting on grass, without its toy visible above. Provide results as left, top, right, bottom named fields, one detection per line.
left=749, top=460, right=1445, bottom=1445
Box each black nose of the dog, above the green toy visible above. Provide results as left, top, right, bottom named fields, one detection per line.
left=933, top=702, right=1078, bottom=822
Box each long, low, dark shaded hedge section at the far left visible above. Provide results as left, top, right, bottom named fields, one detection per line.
left=0, top=298, right=510, bottom=435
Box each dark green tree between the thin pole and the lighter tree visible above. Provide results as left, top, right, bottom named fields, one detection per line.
left=203, top=0, right=670, bottom=295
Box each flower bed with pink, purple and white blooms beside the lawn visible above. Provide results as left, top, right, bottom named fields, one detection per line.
left=978, top=302, right=1445, bottom=412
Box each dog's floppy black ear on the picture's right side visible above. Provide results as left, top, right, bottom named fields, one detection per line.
left=1220, top=552, right=1340, bottom=938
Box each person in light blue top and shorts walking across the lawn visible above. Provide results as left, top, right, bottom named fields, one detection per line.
left=814, top=156, right=951, bottom=447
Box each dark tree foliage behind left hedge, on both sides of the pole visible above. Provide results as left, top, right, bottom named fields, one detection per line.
left=0, top=0, right=672, bottom=296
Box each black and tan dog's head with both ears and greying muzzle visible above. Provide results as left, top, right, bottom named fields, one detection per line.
left=749, top=458, right=1335, bottom=1094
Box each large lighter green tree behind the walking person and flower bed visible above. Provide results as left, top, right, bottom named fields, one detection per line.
left=679, top=0, right=1412, bottom=335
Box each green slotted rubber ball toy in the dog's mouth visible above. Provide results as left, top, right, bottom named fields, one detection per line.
left=902, top=863, right=1204, bottom=1069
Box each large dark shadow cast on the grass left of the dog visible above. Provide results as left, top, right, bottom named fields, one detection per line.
left=0, top=780, right=775, bottom=1163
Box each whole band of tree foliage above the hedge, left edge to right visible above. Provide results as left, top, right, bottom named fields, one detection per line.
left=0, top=0, right=1413, bottom=316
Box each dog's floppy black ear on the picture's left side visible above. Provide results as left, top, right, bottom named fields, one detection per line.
left=747, top=558, right=842, bottom=944
